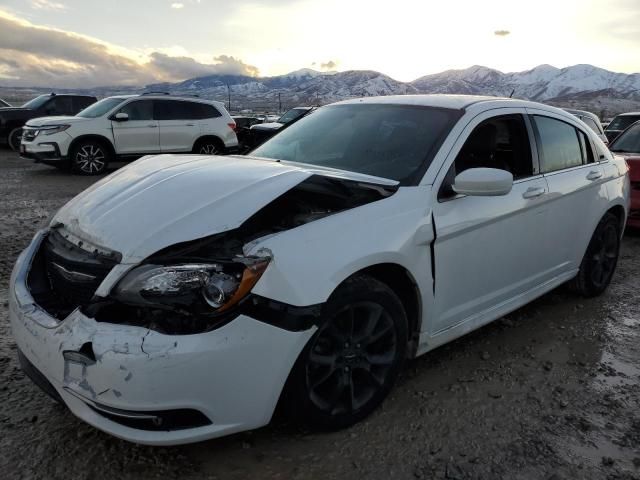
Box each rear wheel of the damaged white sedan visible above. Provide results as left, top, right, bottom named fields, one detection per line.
left=569, top=213, right=620, bottom=297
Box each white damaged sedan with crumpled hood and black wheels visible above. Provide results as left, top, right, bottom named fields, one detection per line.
left=9, top=95, right=629, bottom=445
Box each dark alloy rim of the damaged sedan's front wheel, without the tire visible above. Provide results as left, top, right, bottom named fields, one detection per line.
left=306, top=301, right=398, bottom=415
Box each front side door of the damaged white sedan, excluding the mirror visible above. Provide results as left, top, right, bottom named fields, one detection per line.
left=432, top=108, right=550, bottom=333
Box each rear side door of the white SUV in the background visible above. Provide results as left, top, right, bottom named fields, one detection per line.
left=155, top=100, right=201, bottom=152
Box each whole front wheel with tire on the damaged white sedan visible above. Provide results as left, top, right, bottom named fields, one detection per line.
left=285, top=275, right=407, bottom=430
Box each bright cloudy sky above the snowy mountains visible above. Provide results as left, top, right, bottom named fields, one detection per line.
left=0, top=0, right=640, bottom=87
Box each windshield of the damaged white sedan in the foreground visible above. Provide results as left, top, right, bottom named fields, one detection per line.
left=251, top=104, right=461, bottom=185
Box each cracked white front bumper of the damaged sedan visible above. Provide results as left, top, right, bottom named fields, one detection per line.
left=9, top=234, right=315, bottom=445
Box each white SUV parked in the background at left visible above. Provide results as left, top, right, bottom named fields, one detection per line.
left=20, top=93, right=238, bottom=175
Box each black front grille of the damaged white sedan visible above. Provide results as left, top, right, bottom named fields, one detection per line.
left=27, top=230, right=117, bottom=318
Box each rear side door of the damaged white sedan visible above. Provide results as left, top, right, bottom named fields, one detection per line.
left=528, top=109, right=608, bottom=274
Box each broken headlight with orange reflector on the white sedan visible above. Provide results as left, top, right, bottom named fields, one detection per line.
left=112, top=257, right=271, bottom=315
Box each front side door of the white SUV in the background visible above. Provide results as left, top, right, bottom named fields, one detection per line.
left=111, top=100, right=160, bottom=155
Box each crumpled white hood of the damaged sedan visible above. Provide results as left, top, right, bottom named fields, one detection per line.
left=51, top=155, right=312, bottom=263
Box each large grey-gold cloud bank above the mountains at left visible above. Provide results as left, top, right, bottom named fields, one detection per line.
left=0, top=11, right=259, bottom=88
